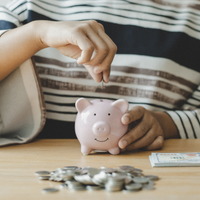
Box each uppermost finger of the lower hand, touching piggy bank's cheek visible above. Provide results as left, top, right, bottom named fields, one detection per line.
left=121, top=106, right=145, bottom=125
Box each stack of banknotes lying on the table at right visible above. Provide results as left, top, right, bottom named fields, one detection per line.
left=149, top=152, right=200, bottom=167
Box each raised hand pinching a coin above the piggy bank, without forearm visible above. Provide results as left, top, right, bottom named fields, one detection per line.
left=38, top=20, right=117, bottom=83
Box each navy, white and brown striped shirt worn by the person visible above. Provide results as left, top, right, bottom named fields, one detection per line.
left=0, top=0, right=200, bottom=138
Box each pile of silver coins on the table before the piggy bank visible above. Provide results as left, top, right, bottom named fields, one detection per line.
left=35, top=165, right=159, bottom=193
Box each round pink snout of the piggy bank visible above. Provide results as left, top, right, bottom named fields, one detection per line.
left=92, top=121, right=111, bottom=136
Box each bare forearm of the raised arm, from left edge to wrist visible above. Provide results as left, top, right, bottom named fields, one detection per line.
left=0, top=22, right=44, bottom=81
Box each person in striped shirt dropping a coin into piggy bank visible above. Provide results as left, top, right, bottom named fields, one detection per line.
left=0, top=0, right=200, bottom=151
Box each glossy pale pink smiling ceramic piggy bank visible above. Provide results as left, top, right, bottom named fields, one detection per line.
left=75, top=98, right=129, bottom=155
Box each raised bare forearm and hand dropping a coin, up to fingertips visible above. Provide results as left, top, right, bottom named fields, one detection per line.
left=0, top=20, right=117, bottom=83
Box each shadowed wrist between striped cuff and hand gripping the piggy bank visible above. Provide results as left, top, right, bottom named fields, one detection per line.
left=152, top=112, right=180, bottom=139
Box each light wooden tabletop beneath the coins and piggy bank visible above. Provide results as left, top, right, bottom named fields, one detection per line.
left=0, top=139, right=200, bottom=200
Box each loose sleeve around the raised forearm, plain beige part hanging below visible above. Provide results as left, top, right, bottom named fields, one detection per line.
left=0, top=0, right=46, bottom=147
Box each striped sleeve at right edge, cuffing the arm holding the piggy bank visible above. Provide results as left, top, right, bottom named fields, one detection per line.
left=167, top=86, right=200, bottom=139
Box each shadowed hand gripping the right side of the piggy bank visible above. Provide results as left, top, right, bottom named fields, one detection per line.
left=118, top=106, right=167, bottom=151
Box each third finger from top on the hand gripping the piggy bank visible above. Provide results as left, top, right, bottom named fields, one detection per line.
left=126, top=129, right=156, bottom=151
